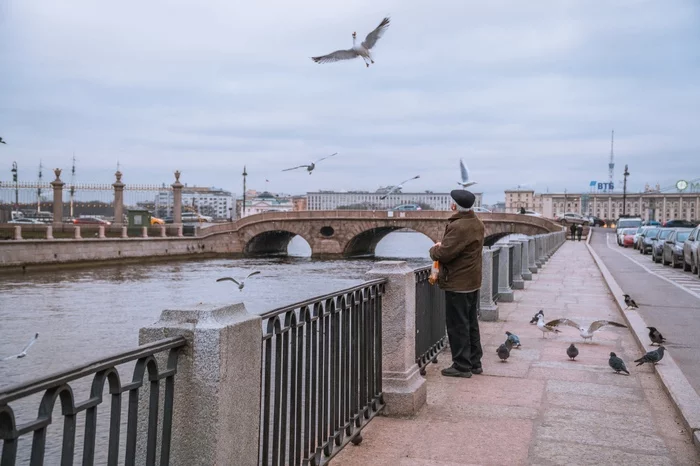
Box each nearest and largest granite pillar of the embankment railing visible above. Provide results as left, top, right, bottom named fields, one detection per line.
left=136, top=303, right=262, bottom=466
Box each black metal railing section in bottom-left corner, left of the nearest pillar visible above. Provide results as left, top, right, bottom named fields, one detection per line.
left=0, top=337, right=187, bottom=466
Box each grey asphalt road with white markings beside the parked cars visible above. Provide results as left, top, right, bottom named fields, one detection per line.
left=591, top=228, right=700, bottom=394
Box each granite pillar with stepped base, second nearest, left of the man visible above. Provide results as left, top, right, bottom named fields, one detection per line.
left=366, top=261, right=427, bottom=416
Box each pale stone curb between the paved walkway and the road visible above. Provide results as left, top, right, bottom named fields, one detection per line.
left=586, top=231, right=700, bottom=452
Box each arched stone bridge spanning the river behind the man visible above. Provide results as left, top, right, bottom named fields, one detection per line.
left=197, top=210, right=562, bottom=257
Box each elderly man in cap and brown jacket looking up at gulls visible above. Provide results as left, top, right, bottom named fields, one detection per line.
left=430, top=189, right=484, bottom=378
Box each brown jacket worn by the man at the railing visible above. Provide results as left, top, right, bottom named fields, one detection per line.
left=430, top=212, right=484, bottom=291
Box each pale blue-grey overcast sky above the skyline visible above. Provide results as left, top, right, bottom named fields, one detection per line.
left=0, top=0, right=700, bottom=203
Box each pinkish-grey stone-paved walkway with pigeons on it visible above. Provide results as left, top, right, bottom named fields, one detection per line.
left=331, top=241, right=700, bottom=466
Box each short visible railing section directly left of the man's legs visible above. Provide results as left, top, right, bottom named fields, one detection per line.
left=414, top=267, right=447, bottom=375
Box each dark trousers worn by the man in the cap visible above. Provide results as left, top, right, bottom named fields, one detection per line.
left=445, top=291, right=484, bottom=371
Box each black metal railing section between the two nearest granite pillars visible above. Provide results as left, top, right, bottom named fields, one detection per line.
left=259, top=279, right=387, bottom=465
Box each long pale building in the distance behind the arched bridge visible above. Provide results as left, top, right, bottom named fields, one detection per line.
left=306, top=191, right=482, bottom=210
